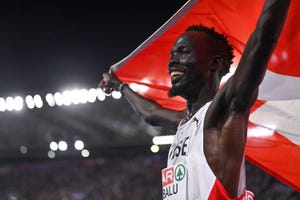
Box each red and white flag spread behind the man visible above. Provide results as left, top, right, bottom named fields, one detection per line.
left=111, top=0, right=300, bottom=191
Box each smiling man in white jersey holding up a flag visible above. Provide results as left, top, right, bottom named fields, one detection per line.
left=99, top=0, right=290, bottom=200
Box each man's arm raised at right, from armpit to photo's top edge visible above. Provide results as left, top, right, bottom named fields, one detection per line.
left=225, top=0, right=290, bottom=111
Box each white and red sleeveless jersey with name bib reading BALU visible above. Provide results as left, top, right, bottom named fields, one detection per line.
left=162, top=102, right=253, bottom=200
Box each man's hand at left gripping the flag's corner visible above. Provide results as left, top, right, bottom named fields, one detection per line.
left=98, top=72, right=122, bottom=94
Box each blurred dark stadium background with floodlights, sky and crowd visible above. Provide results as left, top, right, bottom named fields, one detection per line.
left=0, top=0, right=300, bottom=200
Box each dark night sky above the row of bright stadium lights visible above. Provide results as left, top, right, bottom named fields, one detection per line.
left=0, top=0, right=186, bottom=96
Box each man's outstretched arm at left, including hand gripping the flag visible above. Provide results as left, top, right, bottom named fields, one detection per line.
left=99, top=72, right=185, bottom=131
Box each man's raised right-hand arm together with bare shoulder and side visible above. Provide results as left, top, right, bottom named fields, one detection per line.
left=204, top=0, right=290, bottom=197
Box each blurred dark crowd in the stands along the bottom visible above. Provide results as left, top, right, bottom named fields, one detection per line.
left=0, top=155, right=300, bottom=200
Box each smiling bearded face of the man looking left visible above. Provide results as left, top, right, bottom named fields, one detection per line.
left=168, top=31, right=212, bottom=98
